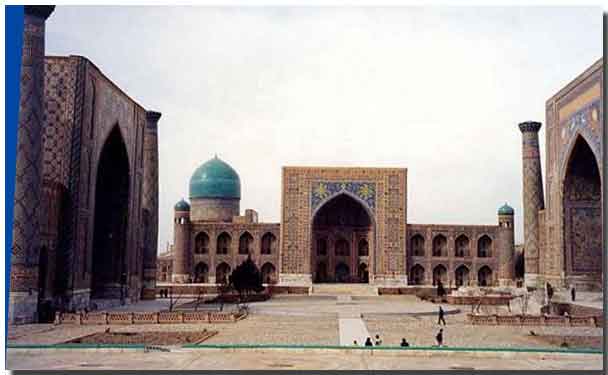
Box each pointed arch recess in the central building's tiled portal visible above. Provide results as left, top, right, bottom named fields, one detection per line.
left=311, top=193, right=374, bottom=283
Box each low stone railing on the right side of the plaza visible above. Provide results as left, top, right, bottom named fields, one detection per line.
left=467, top=314, right=604, bottom=327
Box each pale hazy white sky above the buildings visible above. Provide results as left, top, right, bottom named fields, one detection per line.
left=47, top=6, right=602, bottom=250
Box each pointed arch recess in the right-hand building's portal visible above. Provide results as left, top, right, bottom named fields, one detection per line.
left=563, top=136, right=603, bottom=283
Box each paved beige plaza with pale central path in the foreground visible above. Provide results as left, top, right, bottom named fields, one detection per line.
left=8, top=296, right=603, bottom=369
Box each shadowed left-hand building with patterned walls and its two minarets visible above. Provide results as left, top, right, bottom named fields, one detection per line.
left=9, top=6, right=160, bottom=323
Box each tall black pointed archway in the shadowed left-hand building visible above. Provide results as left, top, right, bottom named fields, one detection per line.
left=91, top=126, right=129, bottom=299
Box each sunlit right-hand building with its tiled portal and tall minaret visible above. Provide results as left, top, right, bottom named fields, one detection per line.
left=520, top=59, right=605, bottom=290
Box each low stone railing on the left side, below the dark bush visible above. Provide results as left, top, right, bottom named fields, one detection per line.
left=55, top=311, right=247, bottom=325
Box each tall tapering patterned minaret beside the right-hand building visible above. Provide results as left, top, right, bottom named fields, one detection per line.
left=519, top=121, right=545, bottom=287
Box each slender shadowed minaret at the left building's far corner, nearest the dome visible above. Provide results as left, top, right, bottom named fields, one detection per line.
left=142, top=111, right=161, bottom=299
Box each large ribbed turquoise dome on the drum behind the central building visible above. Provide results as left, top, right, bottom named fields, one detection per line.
left=190, top=156, right=241, bottom=199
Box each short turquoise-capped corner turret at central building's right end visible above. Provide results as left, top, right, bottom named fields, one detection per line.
left=498, top=203, right=515, bottom=286
